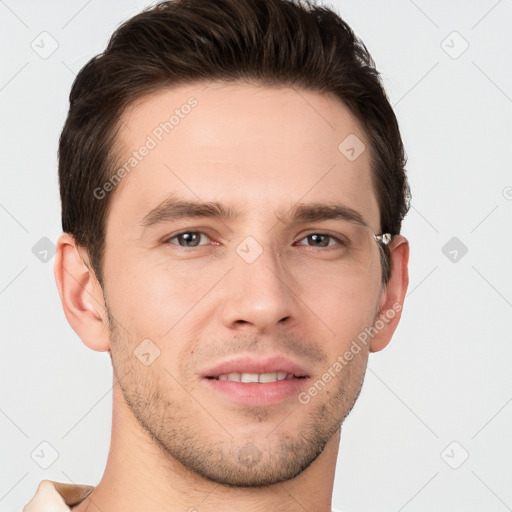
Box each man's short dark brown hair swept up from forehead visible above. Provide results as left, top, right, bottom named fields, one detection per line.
left=59, top=0, right=410, bottom=284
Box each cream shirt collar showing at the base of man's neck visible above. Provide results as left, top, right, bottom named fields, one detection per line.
left=22, top=480, right=342, bottom=512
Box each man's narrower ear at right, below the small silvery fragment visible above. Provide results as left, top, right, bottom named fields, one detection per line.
left=370, top=235, right=409, bottom=352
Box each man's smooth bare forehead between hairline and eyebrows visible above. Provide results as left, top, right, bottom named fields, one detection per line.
left=111, top=82, right=379, bottom=230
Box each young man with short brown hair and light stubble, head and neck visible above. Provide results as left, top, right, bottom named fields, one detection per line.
left=24, top=0, right=409, bottom=512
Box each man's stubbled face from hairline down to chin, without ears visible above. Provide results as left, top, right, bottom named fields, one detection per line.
left=103, top=83, right=382, bottom=486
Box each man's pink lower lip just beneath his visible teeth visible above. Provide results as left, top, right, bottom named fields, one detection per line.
left=203, top=377, right=309, bottom=406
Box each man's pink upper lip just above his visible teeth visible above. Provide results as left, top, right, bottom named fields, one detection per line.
left=201, top=356, right=309, bottom=377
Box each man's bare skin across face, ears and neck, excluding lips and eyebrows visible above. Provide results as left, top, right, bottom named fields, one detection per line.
left=55, top=83, right=409, bottom=512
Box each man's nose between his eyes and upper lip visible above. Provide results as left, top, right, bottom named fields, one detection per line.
left=222, top=241, right=300, bottom=334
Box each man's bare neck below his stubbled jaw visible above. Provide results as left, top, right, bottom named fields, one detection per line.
left=73, top=381, right=340, bottom=512
